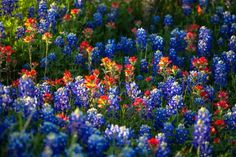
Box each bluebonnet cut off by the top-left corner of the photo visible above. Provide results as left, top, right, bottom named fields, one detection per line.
left=1, top=0, right=18, bottom=15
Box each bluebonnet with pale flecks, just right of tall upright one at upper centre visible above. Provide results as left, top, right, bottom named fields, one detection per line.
left=149, top=34, right=164, bottom=51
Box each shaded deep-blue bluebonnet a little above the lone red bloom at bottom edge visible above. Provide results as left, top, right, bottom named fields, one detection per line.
left=154, top=108, right=169, bottom=129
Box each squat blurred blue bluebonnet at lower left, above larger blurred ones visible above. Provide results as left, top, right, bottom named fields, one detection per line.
left=40, top=121, right=59, bottom=135
